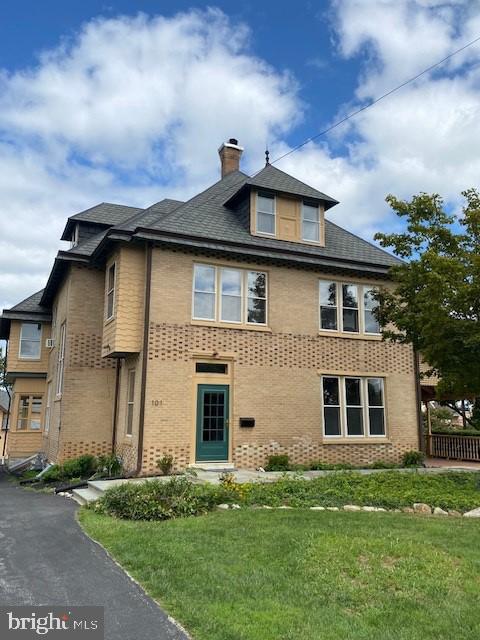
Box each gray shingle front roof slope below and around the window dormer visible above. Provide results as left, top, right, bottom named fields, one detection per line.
left=141, top=171, right=399, bottom=267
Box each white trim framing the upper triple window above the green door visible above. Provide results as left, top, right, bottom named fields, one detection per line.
left=192, top=262, right=269, bottom=327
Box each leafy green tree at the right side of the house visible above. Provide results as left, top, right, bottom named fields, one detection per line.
left=375, top=189, right=480, bottom=424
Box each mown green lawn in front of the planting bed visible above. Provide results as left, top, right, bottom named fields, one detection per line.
left=80, top=509, right=480, bottom=640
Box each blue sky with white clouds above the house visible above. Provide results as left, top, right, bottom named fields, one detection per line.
left=0, top=0, right=480, bottom=306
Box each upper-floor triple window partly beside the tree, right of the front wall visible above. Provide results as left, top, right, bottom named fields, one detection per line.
left=319, top=280, right=380, bottom=335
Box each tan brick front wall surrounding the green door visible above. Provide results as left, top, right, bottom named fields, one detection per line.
left=137, top=250, right=418, bottom=473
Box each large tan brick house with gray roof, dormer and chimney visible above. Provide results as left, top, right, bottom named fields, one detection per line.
left=0, top=139, right=419, bottom=473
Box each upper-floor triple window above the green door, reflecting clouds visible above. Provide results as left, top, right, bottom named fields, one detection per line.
left=192, top=264, right=267, bottom=324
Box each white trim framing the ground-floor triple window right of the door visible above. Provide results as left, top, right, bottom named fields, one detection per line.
left=320, top=373, right=388, bottom=441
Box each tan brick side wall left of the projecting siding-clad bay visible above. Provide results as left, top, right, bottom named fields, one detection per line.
left=44, top=265, right=115, bottom=461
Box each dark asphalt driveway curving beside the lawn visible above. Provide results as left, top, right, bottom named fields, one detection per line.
left=0, top=473, right=186, bottom=640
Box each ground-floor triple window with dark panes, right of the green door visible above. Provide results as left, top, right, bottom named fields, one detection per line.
left=322, top=376, right=385, bottom=438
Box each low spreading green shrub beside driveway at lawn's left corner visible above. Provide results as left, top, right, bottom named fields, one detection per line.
left=96, top=477, right=217, bottom=520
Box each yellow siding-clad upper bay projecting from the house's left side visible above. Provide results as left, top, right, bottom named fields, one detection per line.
left=102, top=247, right=145, bottom=356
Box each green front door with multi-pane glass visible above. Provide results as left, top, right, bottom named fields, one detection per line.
left=196, top=384, right=229, bottom=462
